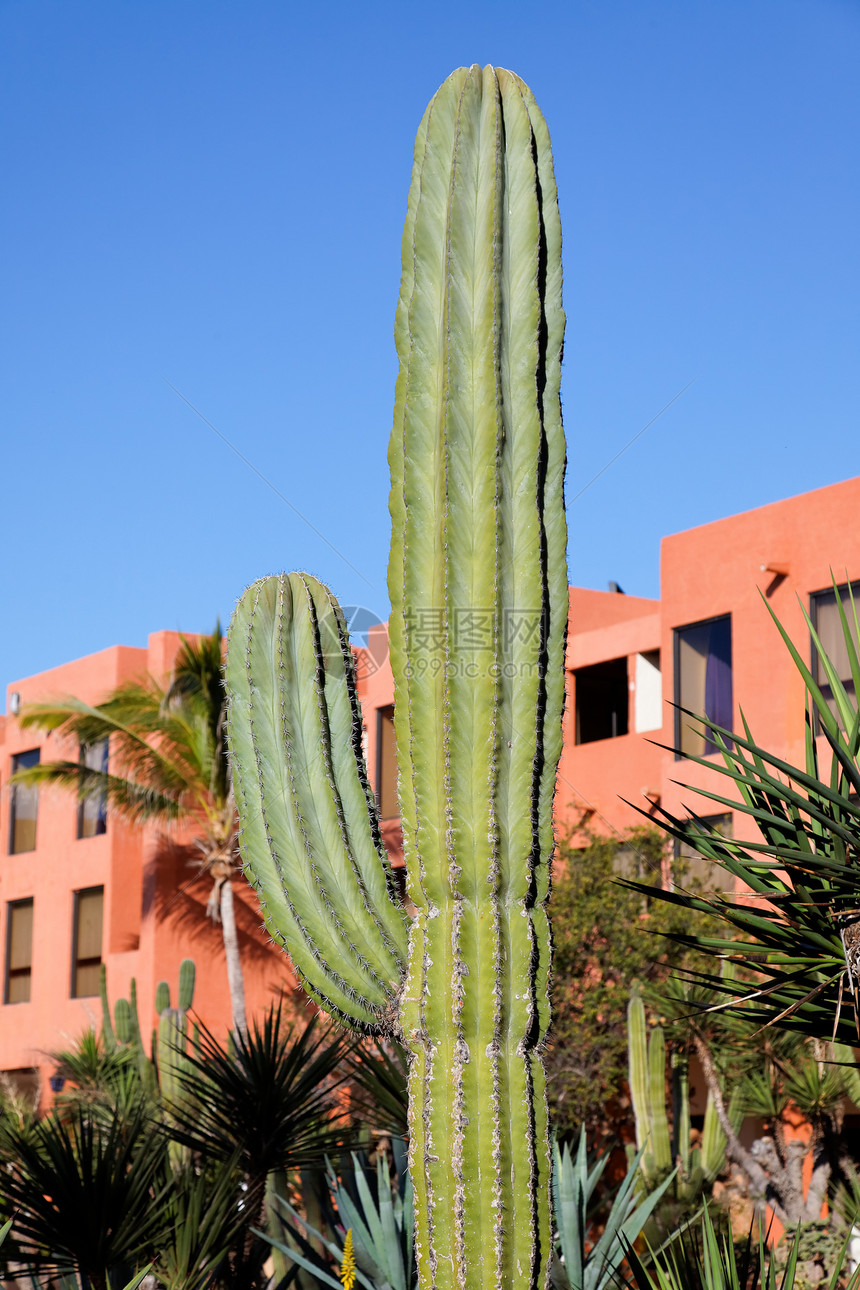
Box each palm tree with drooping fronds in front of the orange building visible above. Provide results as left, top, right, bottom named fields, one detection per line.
left=13, top=624, right=248, bottom=1035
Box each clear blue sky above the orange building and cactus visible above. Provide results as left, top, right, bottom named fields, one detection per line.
left=0, top=0, right=860, bottom=702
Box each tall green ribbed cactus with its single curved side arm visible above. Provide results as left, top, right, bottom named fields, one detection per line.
left=227, top=67, right=567, bottom=1290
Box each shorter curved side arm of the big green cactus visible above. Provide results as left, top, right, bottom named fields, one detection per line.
left=227, top=574, right=406, bottom=1027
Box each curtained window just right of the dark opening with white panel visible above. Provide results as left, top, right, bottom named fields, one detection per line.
left=674, top=614, right=734, bottom=757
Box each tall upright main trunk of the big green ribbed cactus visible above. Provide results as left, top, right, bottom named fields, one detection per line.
left=389, top=68, right=567, bottom=1287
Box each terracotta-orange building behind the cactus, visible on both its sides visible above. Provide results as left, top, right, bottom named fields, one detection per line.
left=0, top=479, right=860, bottom=1089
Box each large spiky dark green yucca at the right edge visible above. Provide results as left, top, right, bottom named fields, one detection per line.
left=621, top=591, right=860, bottom=1044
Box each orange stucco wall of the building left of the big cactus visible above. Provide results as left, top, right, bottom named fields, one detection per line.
left=0, top=632, right=295, bottom=1097
